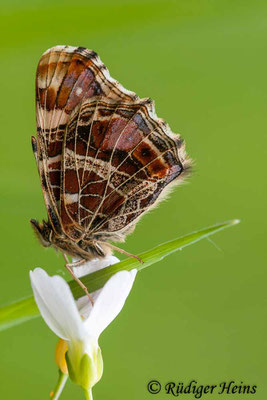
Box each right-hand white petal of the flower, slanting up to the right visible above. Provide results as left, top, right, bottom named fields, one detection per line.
left=84, top=269, right=137, bottom=338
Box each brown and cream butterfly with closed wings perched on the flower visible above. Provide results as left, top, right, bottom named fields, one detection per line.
left=31, top=46, right=190, bottom=296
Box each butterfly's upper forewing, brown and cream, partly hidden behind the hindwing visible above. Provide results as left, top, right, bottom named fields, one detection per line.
left=33, top=46, right=137, bottom=236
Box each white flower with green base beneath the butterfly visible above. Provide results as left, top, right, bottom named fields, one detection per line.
left=30, top=256, right=137, bottom=396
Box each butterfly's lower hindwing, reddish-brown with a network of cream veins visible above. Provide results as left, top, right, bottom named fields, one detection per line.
left=61, top=98, right=187, bottom=241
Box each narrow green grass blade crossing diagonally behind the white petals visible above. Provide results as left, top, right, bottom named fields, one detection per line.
left=0, top=220, right=239, bottom=331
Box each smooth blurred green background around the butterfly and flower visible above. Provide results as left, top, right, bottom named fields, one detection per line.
left=0, top=0, right=267, bottom=400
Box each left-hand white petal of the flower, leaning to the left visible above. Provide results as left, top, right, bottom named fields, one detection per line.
left=30, top=268, right=86, bottom=340
